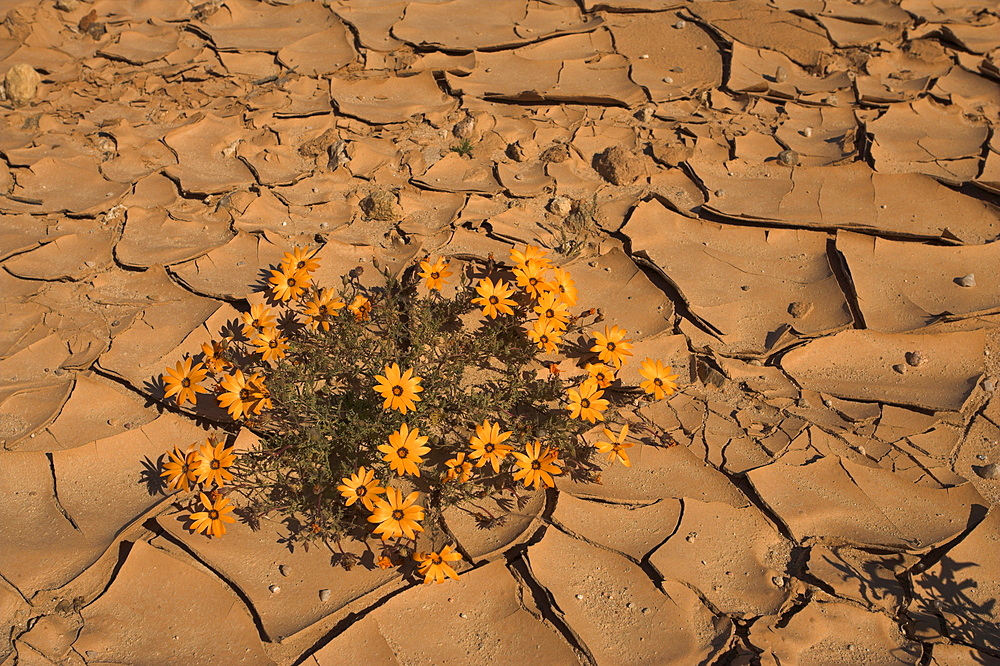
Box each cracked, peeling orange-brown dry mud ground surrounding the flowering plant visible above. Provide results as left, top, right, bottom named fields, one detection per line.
left=0, top=0, right=1000, bottom=666
